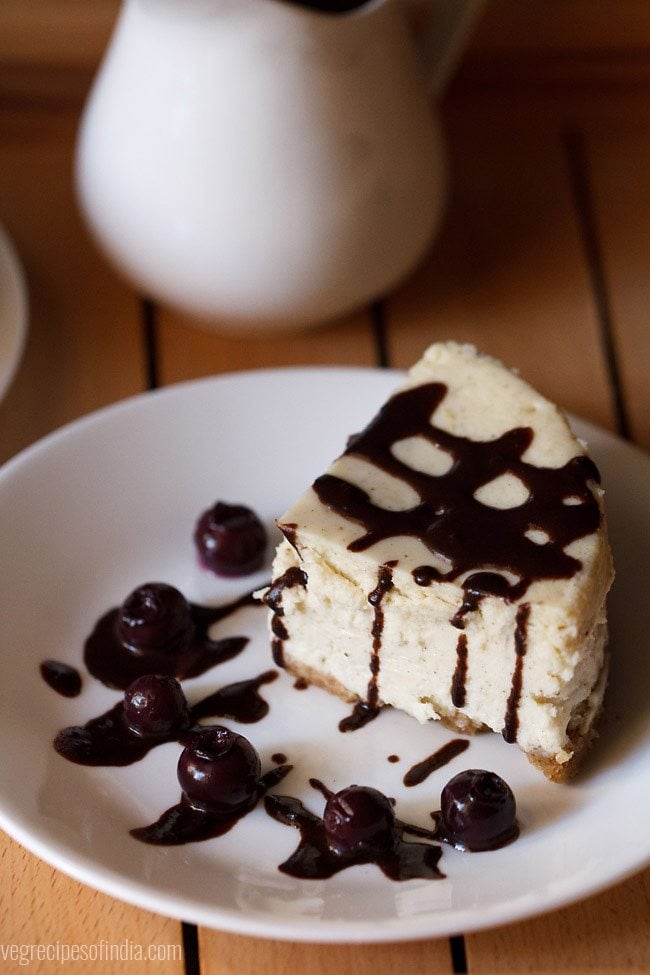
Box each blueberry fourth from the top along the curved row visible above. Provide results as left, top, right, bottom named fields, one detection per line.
left=178, top=725, right=261, bottom=814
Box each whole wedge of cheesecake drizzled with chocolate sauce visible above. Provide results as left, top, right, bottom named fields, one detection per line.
left=265, top=342, right=613, bottom=781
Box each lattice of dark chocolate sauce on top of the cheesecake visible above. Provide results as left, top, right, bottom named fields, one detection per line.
left=314, top=383, right=600, bottom=600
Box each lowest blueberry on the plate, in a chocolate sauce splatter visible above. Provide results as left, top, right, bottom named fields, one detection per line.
left=323, top=785, right=395, bottom=856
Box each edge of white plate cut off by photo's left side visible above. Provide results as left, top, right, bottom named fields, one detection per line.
left=0, top=224, right=27, bottom=400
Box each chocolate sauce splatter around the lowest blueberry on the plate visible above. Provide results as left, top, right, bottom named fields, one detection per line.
left=264, top=779, right=444, bottom=880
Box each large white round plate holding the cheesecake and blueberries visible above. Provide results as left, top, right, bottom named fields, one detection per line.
left=0, top=369, right=650, bottom=942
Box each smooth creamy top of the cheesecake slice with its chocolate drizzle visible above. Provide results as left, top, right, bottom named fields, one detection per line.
left=278, top=342, right=611, bottom=621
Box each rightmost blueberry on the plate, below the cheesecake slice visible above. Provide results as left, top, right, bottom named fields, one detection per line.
left=441, top=769, right=518, bottom=850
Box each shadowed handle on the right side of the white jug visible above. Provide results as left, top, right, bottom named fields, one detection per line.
left=420, top=0, right=485, bottom=98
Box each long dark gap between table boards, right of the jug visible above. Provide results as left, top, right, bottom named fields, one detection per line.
left=562, top=126, right=630, bottom=440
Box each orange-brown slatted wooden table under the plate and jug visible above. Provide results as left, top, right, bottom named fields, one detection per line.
left=0, top=80, right=650, bottom=975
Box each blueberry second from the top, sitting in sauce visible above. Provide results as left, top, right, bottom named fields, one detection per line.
left=117, top=582, right=193, bottom=652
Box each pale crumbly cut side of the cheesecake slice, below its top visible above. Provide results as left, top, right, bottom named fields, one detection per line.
left=274, top=541, right=607, bottom=764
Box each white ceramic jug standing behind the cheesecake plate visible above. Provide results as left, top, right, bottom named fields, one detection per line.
left=76, top=0, right=475, bottom=328
